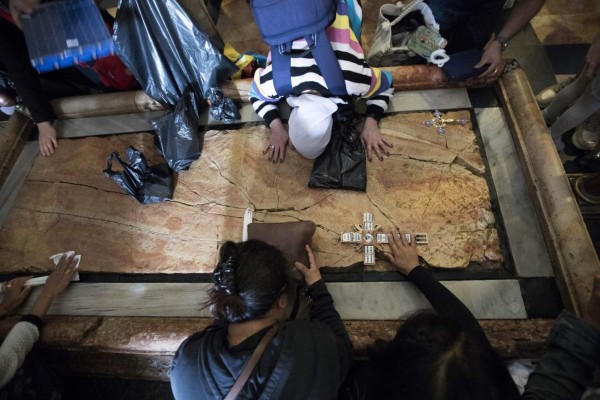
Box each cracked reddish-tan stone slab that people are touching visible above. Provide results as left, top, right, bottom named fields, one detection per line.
left=0, top=111, right=502, bottom=273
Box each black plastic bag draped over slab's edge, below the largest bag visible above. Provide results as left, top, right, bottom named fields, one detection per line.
left=152, top=90, right=204, bottom=172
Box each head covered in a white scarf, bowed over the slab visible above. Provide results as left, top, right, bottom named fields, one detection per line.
left=287, top=93, right=338, bottom=159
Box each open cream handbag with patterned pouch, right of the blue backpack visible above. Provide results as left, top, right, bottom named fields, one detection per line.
left=367, top=0, right=447, bottom=67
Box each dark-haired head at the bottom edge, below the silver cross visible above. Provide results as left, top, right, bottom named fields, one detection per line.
left=369, top=312, right=520, bottom=400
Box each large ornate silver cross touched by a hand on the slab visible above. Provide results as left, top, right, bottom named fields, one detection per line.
left=341, top=213, right=429, bottom=265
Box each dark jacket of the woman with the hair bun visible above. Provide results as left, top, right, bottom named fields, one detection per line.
left=171, top=280, right=352, bottom=400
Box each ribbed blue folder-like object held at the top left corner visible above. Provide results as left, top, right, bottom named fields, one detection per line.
left=21, top=0, right=115, bottom=73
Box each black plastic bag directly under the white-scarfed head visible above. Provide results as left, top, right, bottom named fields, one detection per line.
left=308, top=105, right=367, bottom=192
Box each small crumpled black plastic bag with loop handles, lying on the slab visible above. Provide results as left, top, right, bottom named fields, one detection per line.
left=104, top=146, right=174, bottom=204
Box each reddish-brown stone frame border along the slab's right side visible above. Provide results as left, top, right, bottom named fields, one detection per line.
left=496, top=62, right=600, bottom=316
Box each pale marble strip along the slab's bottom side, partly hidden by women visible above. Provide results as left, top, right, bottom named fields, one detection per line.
left=5, top=280, right=527, bottom=320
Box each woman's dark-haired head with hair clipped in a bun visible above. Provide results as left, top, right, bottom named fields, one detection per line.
left=207, top=240, right=289, bottom=323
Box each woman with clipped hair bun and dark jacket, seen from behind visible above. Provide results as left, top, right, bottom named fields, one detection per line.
left=171, top=240, right=352, bottom=400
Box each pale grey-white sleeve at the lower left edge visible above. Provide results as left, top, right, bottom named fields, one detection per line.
left=0, top=321, right=40, bottom=388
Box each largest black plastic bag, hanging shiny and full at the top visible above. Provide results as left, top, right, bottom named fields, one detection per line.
left=113, top=0, right=237, bottom=108
